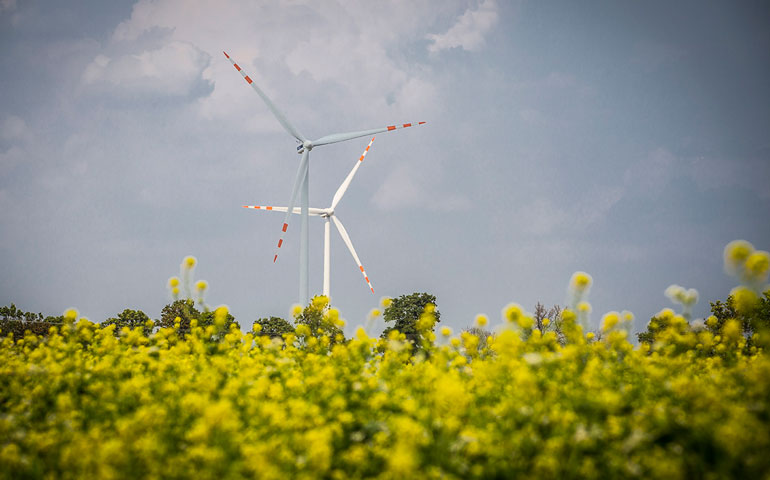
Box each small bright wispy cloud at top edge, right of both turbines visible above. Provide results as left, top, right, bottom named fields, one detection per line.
left=426, top=0, right=498, bottom=52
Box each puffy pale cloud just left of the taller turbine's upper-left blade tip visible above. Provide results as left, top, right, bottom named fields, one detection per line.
left=82, top=41, right=211, bottom=97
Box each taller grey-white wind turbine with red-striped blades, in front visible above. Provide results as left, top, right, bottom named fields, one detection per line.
left=222, top=52, right=425, bottom=305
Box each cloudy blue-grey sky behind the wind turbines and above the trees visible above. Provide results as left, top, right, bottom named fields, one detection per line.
left=0, top=0, right=770, bottom=333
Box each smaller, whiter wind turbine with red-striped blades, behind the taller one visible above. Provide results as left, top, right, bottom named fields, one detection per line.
left=243, top=137, right=374, bottom=300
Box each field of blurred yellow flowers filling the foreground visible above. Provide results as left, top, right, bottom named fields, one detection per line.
left=0, top=244, right=770, bottom=479
